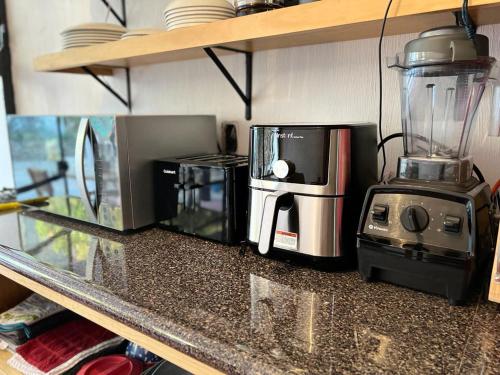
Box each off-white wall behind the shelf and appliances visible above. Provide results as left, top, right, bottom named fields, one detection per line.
left=2, top=0, right=500, bottom=182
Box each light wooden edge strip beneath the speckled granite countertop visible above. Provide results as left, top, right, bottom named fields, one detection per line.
left=0, top=265, right=223, bottom=375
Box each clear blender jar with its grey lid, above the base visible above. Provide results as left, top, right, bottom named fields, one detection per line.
left=391, top=26, right=500, bottom=184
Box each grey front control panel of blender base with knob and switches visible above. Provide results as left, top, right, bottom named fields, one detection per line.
left=363, top=193, right=473, bottom=252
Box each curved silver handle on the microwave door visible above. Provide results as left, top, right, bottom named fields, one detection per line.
left=75, top=117, right=97, bottom=222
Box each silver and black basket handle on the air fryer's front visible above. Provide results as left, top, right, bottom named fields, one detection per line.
left=259, top=192, right=292, bottom=255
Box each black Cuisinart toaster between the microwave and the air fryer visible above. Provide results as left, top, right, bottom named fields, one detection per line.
left=155, top=154, right=248, bottom=244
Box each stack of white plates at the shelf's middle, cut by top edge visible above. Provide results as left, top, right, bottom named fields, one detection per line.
left=163, top=0, right=235, bottom=30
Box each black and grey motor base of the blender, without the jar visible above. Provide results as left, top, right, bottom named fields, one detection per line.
left=358, top=183, right=493, bottom=305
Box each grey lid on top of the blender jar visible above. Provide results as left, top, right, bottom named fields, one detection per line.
left=401, top=26, right=489, bottom=67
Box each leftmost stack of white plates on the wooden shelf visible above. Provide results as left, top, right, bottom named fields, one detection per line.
left=61, top=23, right=127, bottom=49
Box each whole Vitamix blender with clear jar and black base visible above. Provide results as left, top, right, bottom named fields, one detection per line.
left=358, top=26, right=500, bottom=304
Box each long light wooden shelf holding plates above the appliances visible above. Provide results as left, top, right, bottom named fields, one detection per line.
left=34, top=0, right=500, bottom=74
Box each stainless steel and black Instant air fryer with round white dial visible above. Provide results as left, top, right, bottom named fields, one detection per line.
left=248, top=124, right=377, bottom=259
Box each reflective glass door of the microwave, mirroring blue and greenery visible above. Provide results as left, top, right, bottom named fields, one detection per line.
left=8, top=116, right=97, bottom=220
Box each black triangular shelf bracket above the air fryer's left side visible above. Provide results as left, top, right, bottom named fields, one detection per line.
left=204, top=46, right=253, bottom=120
